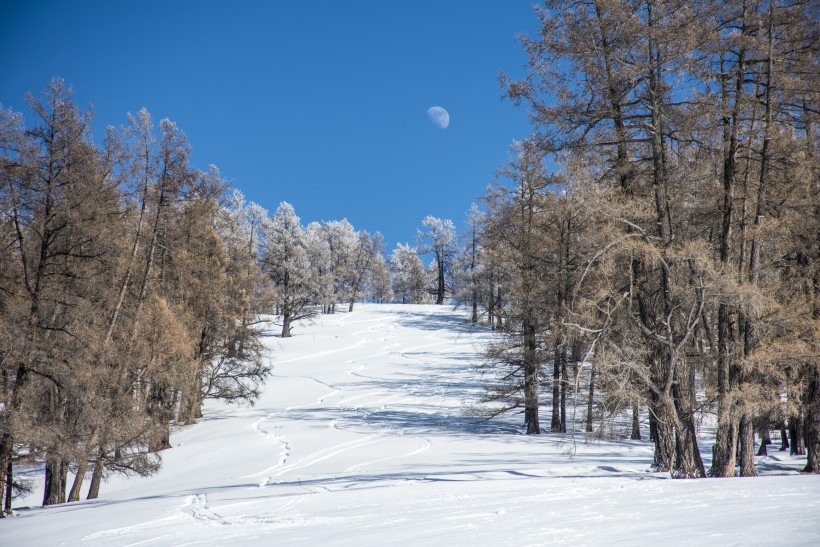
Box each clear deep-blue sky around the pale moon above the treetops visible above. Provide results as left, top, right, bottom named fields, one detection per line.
left=0, top=0, right=537, bottom=250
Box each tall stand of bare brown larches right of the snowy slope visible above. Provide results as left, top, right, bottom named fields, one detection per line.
left=471, top=0, right=820, bottom=478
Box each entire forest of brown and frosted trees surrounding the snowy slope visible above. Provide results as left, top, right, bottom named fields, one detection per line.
left=0, top=0, right=820, bottom=514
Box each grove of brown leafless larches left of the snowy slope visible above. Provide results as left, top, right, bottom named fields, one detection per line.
left=0, top=83, right=278, bottom=514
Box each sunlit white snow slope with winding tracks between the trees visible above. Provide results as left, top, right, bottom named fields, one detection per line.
left=6, top=305, right=820, bottom=546
